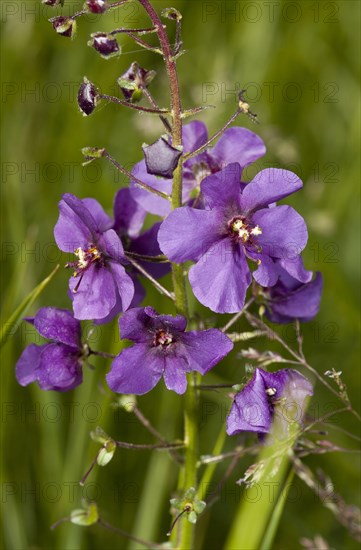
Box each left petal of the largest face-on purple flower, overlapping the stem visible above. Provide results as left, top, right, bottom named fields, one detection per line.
left=158, top=206, right=222, bottom=263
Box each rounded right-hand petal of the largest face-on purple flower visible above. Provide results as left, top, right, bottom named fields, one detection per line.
left=252, top=205, right=308, bottom=260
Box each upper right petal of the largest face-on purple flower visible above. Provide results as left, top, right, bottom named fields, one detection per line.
left=241, top=168, right=303, bottom=212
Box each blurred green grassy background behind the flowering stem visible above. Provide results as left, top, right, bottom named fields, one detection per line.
left=1, top=0, right=360, bottom=550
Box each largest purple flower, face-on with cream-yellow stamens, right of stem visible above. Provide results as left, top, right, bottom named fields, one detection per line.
left=158, top=164, right=308, bottom=313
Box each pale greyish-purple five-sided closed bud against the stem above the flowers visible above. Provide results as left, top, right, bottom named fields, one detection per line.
left=143, top=137, right=182, bottom=179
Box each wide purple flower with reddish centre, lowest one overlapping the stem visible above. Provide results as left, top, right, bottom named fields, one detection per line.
left=106, top=307, right=233, bottom=395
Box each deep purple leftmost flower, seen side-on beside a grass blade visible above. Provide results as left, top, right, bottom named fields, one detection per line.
left=16, top=307, right=87, bottom=391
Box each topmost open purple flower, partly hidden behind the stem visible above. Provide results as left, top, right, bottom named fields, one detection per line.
left=131, top=120, right=266, bottom=216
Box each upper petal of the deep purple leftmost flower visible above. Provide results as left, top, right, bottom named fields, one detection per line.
left=34, top=307, right=81, bottom=348
